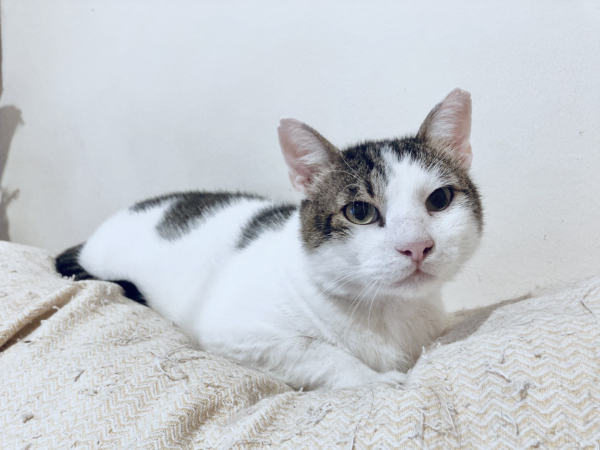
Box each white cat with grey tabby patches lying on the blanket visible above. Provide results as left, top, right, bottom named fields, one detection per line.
left=56, top=89, right=483, bottom=390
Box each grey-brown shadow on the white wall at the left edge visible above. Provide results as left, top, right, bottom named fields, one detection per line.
left=0, top=17, right=23, bottom=241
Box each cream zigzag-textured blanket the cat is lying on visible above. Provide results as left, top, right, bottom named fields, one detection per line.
left=0, top=243, right=600, bottom=449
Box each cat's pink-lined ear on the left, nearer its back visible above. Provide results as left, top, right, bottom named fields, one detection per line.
left=277, top=119, right=339, bottom=193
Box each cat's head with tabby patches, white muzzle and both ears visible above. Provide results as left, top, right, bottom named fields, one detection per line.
left=278, top=89, right=483, bottom=301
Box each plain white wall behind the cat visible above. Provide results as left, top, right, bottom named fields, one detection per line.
left=0, top=0, right=600, bottom=308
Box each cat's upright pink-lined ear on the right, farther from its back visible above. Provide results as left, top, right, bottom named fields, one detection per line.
left=417, top=89, right=473, bottom=169
